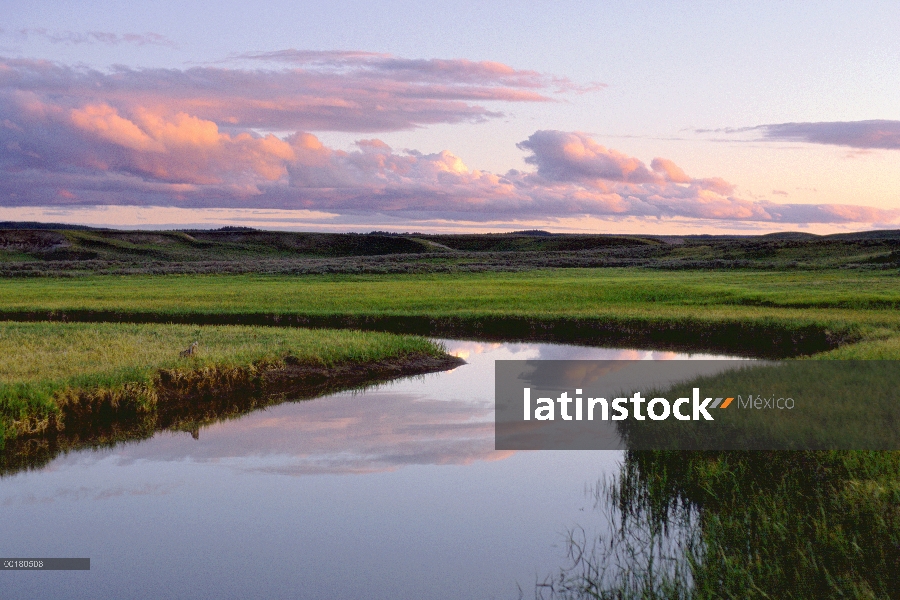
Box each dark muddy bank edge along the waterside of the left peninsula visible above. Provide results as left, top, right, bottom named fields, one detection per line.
left=0, top=354, right=465, bottom=476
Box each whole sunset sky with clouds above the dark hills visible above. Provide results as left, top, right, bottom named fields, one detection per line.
left=0, top=0, right=900, bottom=234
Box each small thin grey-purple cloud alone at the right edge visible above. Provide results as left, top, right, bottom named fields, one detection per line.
left=724, top=120, right=900, bottom=150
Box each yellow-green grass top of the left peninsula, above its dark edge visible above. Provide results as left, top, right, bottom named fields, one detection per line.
left=0, top=322, right=442, bottom=443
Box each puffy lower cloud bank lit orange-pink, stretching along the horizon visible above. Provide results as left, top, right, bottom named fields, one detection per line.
left=0, top=120, right=898, bottom=223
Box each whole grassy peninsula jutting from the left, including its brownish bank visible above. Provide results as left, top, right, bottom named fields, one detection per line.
left=0, top=323, right=445, bottom=454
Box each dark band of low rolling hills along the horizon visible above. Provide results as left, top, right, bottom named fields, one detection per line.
left=0, top=221, right=900, bottom=277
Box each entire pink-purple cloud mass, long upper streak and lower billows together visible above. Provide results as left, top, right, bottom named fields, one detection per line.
left=0, top=50, right=898, bottom=229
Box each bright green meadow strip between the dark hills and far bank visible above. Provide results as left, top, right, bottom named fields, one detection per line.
left=0, top=269, right=900, bottom=358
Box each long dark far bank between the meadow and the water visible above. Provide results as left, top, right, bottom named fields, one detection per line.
left=0, top=309, right=852, bottom=358
